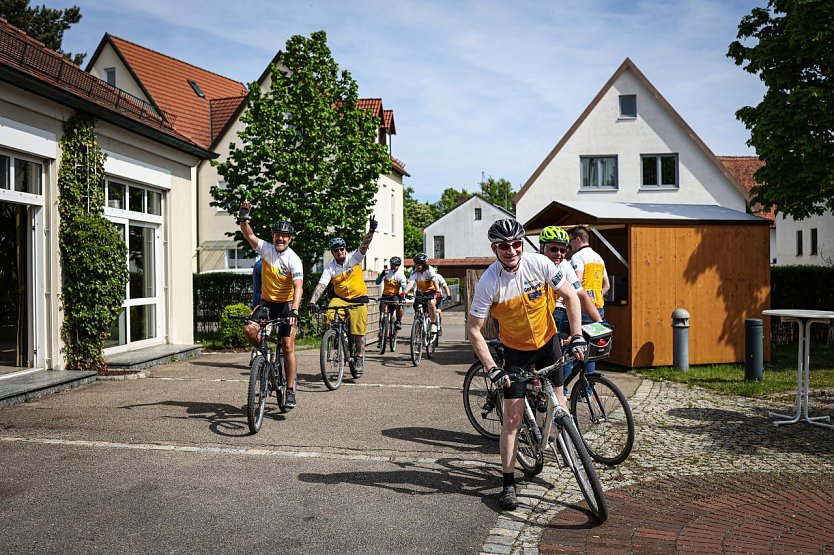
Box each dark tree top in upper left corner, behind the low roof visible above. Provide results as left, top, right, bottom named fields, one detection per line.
left=0, top=0, right=87, bottom=65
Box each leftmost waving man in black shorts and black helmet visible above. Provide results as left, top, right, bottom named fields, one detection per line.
left=237, top=201, right=304, bottom=409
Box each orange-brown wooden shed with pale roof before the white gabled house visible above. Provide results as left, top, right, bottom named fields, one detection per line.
left=524, top=201, right=770, bottom=368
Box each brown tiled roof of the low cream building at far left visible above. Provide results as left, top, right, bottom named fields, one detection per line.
left=0, top=18, right=210, bottom=157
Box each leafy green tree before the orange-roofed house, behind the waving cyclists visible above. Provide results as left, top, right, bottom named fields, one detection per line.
left=211, top=31, right=391, bottom=271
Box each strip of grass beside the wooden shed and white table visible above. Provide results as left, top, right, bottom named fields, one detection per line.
left=635, top=344, right=834, bottom=397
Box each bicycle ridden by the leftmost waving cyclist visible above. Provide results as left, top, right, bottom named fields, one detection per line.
left=230, top=309, right=289, bottom=434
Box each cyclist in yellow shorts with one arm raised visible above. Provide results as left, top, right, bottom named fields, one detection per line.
left=307, top=216, right=379, bottom=376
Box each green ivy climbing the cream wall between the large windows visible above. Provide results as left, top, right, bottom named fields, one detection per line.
left=58, top=114, right=128, bottom=372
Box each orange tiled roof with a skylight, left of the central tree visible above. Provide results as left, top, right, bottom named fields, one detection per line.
left=106, top=35, right=247, bottom=148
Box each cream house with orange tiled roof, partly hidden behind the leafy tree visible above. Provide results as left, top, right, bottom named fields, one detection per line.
left=87, top=34, right=408, bottom=272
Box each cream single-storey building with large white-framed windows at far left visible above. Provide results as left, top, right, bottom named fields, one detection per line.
left=0, top=19, right=215, bottom=373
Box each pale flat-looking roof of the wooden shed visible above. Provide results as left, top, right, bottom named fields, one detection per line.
left=524, top=200, right=770, bottom=232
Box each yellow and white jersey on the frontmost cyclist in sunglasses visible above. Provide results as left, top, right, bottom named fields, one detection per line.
left=469, top=252, right=565, bottom=351
